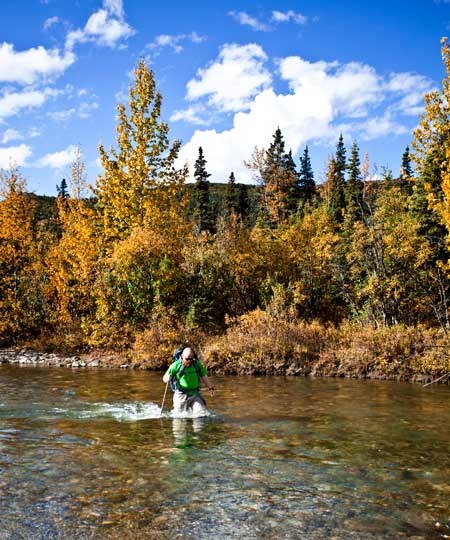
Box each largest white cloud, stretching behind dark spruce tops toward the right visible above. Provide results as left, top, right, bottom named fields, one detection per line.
left=179, top=49, right=431, bottom=182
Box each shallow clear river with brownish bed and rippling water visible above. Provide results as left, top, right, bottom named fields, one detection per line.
left=0, top=366, right=450, bottom=540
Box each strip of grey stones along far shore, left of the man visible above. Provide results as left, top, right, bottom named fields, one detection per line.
left=0, top=349, right=131, bottom=369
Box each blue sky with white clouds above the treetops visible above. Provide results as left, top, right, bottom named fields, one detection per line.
left=0, top=0, right=450, bottom=195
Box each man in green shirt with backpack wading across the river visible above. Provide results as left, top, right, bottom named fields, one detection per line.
left=163, top=347, right=214, bottom=416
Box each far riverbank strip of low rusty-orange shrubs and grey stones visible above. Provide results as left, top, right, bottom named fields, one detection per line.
left=0, top=311, right=450, bottom=384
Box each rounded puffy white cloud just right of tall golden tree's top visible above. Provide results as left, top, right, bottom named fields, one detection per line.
left=187, top=43, right=272, bottom=112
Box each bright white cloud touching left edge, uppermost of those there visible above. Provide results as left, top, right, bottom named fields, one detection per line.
left=0, top=42, right=75, bottom=84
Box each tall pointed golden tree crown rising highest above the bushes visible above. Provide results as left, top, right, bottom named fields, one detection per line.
left=94, top=59, right=186, bottom=242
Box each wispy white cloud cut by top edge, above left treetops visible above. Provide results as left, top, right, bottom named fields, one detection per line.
left=66, top=0, right=135, bottom=51
